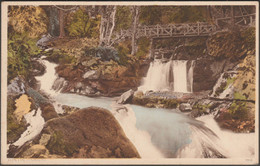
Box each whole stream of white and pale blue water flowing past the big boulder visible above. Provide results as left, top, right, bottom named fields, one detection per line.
left=11, top=59, right=255, bottom=158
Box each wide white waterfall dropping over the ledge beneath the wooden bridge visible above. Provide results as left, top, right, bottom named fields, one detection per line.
left=138, top=59, right=194, bottom=93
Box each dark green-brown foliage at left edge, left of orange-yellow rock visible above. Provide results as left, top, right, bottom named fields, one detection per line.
left=7, top=96, right=26, bottom=143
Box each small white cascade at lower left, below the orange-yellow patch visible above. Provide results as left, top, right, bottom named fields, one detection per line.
left=13, top=108, right=45, bottom=147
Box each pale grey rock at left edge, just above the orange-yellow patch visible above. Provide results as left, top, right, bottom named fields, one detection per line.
left=7, top=76, right=25, bottom=95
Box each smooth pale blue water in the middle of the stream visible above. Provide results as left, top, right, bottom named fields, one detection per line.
left=56, top=94, right=191, bottom=157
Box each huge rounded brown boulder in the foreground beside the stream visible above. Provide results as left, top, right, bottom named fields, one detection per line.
left=38, top=107, right=140, bottom=158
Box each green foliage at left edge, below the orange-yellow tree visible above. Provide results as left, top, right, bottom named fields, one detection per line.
left=7, top=33, right=41, bottom=81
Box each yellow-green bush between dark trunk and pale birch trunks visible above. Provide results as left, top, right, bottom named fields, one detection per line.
left=66, top=8, right=100, bottom=38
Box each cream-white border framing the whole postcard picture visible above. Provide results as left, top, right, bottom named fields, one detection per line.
left=1, top=1, right=259, bottom=165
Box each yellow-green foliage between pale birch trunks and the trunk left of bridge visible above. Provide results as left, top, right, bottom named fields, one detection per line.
left=115, top=6, right=132, bottom=32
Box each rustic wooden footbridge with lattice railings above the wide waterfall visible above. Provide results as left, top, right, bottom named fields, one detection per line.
left=114, top=22, right=216, bottom=42
